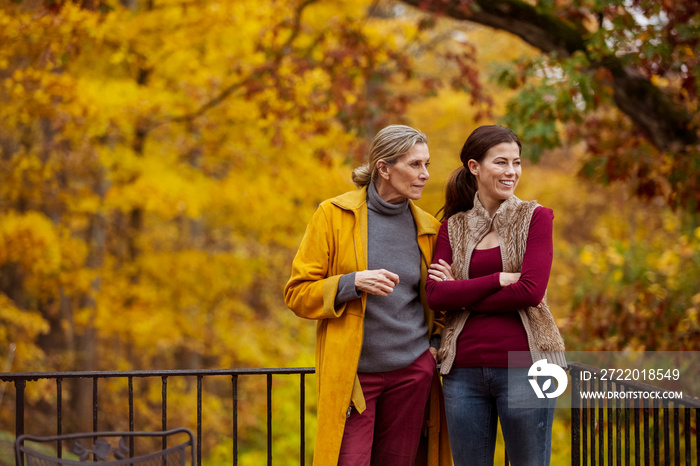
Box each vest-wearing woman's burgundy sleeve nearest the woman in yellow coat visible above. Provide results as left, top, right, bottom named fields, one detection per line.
left=425, top=221, right=501, bottom=311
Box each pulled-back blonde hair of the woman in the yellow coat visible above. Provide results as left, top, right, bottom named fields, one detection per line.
left=352, top=125, right=428, bottom=188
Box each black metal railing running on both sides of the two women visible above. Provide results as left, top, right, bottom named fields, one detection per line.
left=0, top=362, right=700, bottom=466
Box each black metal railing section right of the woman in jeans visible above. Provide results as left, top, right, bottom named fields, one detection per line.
left=569, top=362, right=700, bottom=466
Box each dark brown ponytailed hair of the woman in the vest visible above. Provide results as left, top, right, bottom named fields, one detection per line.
left=438, top=125, right=522, bottom=220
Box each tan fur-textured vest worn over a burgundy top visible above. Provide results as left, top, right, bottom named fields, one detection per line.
left=438, top=193, right=567, bottom=375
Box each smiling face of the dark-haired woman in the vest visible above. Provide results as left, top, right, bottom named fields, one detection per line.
left=469, top=142, right=522, bottom=206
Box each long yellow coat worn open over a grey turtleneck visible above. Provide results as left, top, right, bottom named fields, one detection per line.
left=284, top=188, right=452, bottom=466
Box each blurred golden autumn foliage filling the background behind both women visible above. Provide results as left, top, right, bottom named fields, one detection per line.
left=0, top=0, right=700, bottom=458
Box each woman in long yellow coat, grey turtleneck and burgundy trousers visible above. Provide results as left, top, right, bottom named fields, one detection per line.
left=284, top=125, right=449, bottom=466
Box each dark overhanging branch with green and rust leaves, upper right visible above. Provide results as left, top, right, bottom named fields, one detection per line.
left=403, top=0, right=700, bottom=212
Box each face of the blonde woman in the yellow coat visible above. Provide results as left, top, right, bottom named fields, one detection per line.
left=377, top=142, right=430, bottom=204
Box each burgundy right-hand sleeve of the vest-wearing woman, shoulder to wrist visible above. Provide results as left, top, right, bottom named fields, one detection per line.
left=470, top=206, right=554, bottom=312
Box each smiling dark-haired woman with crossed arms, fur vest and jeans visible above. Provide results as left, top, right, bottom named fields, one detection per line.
left=427, top=125, right=566, bottom=466
